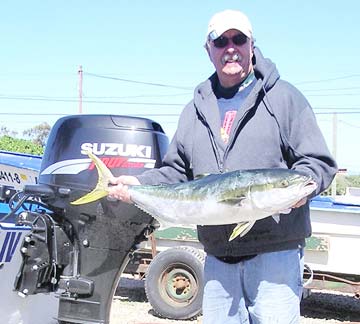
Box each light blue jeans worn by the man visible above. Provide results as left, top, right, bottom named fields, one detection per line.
left=203, top=249, right=304, bottom=324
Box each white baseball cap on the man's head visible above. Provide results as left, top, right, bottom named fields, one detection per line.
left=206, top=10, right=252, bottom=41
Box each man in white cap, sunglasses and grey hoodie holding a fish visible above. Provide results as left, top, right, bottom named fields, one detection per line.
left=110, top=10, right=337, bottom=324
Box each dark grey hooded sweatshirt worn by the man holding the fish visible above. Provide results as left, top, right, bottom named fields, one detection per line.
left=138, top=48, right=337, bottom=257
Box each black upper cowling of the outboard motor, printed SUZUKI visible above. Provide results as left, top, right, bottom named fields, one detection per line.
left=39, top=115, right=168, bottom=205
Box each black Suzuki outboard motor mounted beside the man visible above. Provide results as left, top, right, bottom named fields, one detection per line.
left=15, top=115, right=168, bottom=323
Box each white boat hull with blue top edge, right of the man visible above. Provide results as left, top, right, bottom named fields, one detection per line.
left=305, top=196, right=360, bottom=298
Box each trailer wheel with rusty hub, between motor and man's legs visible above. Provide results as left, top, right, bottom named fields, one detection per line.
left=145, top=246, right=204, bottom=319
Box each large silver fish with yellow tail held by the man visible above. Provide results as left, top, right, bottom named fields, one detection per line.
left=72, top=153, right=317, bottom=240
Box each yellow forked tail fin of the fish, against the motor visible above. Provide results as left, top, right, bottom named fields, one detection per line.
left=70, top=151, right=113, bottom=205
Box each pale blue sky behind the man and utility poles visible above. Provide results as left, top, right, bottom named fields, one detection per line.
left=0, top=0, right=360, bottom=172
